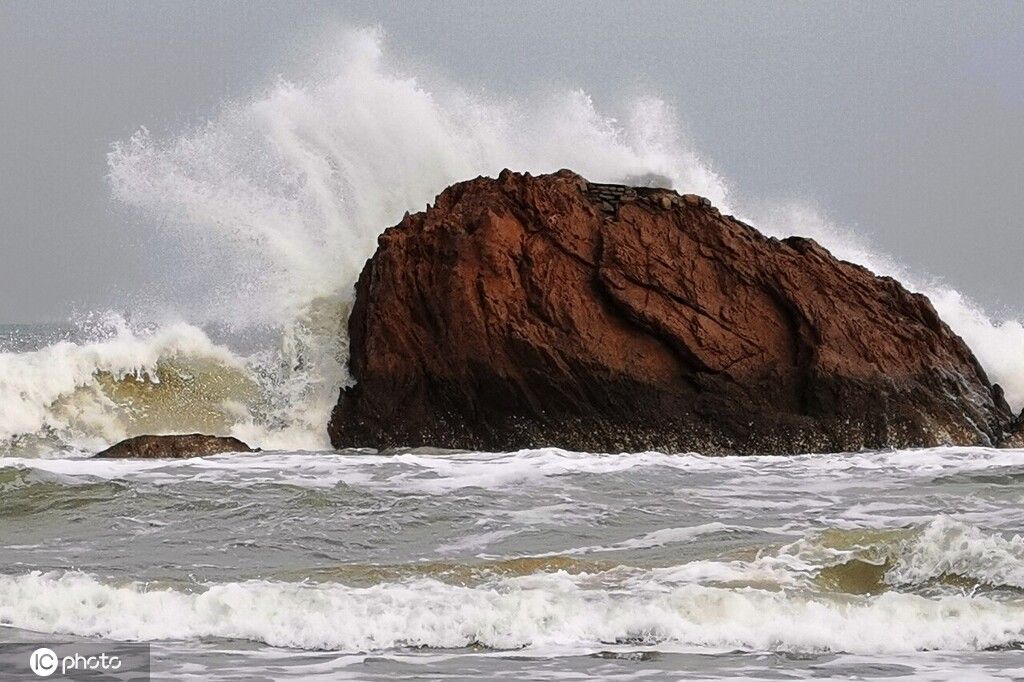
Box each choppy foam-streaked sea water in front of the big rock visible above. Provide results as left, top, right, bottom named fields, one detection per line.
left=0, top=432, right=1024, bottom=680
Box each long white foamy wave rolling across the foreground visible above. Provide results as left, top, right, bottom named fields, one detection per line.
left=0, top=572, right=1024, bottom=653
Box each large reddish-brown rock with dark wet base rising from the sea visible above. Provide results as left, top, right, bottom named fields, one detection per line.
left=329, top=171, right=1013, bottom=454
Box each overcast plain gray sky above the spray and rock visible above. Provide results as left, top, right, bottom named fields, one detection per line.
left=0, top=0, right=1024, bottom=324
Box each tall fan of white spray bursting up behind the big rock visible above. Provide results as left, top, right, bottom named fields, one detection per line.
left=96, top=31, right=726, bottom=447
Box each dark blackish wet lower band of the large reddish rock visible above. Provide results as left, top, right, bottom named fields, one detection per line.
left=334, top=368, right=1007, bottom=455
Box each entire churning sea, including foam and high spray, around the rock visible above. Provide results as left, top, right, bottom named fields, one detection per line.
left=0, top=26, right=1024, bottom=680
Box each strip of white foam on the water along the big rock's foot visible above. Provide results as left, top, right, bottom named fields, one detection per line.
left=6, top=447, right=1024, bottom=489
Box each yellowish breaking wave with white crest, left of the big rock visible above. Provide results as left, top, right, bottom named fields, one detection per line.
left=0, top=299, right=347, bottom=455
